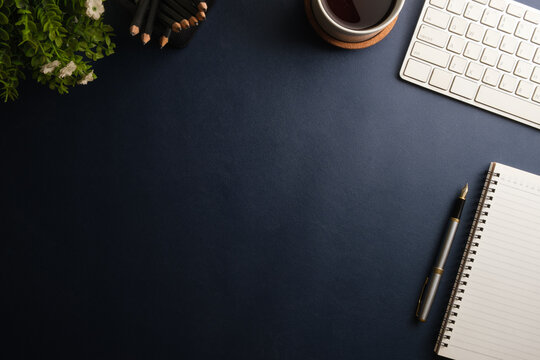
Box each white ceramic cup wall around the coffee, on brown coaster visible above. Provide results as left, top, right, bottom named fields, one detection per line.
left=311, top=0, right=405, bottom=43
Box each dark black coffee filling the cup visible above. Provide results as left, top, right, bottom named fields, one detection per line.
left=323, top=0, right=396, bottom=30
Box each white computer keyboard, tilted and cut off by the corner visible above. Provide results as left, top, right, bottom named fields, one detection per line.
left=400, top=0, right=540, bottom=129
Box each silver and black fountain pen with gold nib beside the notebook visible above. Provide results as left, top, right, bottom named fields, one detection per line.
left=416, top=184, right=469, bottom=322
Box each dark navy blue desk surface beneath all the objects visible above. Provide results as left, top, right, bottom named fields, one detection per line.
left=0, top=0, right=540, bottom=360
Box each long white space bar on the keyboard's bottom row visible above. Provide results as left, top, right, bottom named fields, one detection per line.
left=475, top=85, right=540, bottom=124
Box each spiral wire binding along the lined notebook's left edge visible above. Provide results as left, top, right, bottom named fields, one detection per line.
left=435, top=169, right=500, bottom=352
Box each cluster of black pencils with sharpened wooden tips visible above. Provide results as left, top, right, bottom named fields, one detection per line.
left=129, top=0, right=208, bottom=49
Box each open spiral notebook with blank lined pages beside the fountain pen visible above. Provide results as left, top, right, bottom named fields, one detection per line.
left=435, top=163, right=540, bottom=360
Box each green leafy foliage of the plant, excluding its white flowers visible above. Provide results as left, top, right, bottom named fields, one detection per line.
left=0, top=0, right=115, bottom=101
